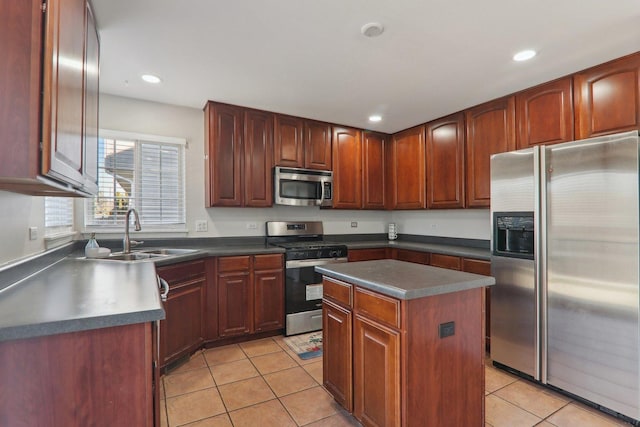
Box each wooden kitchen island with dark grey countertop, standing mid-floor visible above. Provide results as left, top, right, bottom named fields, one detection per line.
left=316, top=260, right=495, bottom=426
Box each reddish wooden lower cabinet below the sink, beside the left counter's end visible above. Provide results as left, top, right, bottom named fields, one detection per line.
left=157, top=260, right=207, bottom=367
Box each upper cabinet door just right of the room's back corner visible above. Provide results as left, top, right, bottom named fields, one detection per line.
left=387, top=126, right=427, bottom=209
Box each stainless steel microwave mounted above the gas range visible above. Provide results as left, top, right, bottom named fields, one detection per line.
left=273, top=166, right=333, bottom=206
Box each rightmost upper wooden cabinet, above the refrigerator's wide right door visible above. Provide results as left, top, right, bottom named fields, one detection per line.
left=574, top=53, right=640, bottom=139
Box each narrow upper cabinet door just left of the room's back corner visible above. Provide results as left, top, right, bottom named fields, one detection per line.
left=362, top=132, right=389, bottom=209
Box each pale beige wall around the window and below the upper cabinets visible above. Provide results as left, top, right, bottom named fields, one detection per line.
left=0, top=94, right=489, bottom=266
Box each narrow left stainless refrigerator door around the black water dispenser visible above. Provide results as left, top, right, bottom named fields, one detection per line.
left=491, top=149, right=539, bottom=378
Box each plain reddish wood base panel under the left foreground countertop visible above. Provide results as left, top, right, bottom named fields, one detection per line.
left=0, top=323, right=155, bottom=427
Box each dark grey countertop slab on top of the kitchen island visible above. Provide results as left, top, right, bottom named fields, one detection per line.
left=315, top=259, right=495, bottom=300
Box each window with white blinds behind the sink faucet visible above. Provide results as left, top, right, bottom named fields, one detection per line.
left=85, top=130, right=186, bottom=229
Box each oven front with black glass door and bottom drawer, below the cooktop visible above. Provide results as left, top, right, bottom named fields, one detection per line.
left=285, top=257, right=347, bottom=335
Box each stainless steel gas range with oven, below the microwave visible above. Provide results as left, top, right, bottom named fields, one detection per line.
left=267, top=221, right=347, bottom=335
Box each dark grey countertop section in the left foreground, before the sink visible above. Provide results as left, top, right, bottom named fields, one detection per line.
left=0, top=258, right=164, bottom=341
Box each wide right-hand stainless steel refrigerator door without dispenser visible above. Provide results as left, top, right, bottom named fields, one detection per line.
left=541, top=132, right=640, bottom=419
